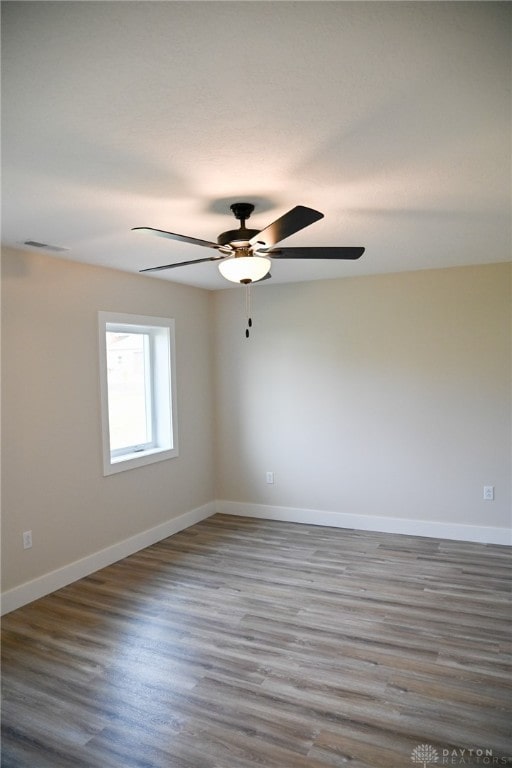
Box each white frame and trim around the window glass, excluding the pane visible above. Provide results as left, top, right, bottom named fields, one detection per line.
left=98, top=311, right=178, bottom=476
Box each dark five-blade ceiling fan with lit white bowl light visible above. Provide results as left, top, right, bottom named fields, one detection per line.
left=133, top=203, right=364, bottom=285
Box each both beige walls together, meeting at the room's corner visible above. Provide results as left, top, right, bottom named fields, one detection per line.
left=2, top=255, right=512, bottom=599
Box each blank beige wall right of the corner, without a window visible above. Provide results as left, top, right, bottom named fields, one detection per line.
left=215, top=264, right=512, bottom=532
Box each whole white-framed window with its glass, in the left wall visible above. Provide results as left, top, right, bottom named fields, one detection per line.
left=99, top=312, right=178, bottom=475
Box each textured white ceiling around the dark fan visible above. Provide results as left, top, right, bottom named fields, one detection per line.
left=2, top=0, right=512, bottom=289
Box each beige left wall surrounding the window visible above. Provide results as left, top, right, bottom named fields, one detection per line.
left=2, top=251, right=214, bottom=591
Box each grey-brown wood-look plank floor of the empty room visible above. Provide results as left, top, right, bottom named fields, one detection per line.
left=2, top=515, right=512, bottom=768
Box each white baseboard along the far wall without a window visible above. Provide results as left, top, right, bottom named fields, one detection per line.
left=216, top=500, right=512, bottom=545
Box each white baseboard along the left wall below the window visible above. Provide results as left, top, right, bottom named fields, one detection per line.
left=1, top=501, right=216, bottom=616
